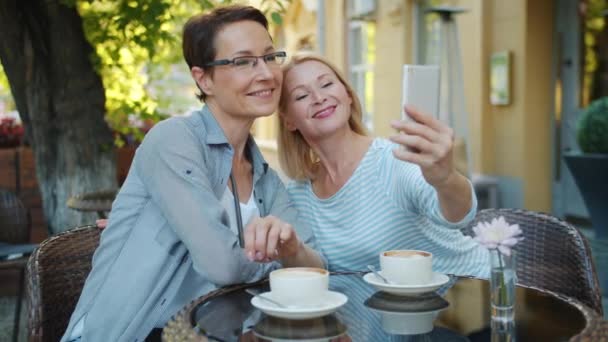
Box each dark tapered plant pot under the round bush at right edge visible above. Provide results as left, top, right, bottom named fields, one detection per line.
left=564, top=153, right=608, bottom=240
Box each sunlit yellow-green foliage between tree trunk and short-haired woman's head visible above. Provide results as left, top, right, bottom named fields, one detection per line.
left=70, top=0, right=289, bottom=146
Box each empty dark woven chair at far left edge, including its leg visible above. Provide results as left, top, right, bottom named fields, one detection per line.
left=0, top=189, right=36, bottom=341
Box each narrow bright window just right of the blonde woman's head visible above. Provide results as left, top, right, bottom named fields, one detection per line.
left=348, top=19, right=376, bottom=131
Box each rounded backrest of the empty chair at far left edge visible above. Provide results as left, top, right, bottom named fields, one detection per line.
left=0, top=188, right=30, bottom=244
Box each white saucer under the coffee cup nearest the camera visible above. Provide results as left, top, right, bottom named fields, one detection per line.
left=251, top=291, right=348, bottom=319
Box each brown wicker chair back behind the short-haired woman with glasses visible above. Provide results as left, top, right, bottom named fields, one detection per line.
left=26, top=226, right=100, bottom=341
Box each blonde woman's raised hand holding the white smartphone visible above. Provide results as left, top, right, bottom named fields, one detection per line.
left=390, top=106, right=456, bottom=189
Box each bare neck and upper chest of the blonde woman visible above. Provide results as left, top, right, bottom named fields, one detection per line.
left=311, top=127, right=372, bottom=184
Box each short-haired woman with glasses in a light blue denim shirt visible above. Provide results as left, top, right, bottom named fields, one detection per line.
left=63, top=6, right=325, bottom=341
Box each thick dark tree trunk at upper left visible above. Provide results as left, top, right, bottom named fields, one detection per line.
left=0, top=0, right=116, bottom=233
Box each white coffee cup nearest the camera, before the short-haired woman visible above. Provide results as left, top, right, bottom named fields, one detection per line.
left=270, top=267, right=329, bottom=307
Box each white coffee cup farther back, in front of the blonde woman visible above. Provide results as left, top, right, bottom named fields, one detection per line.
left=380, top=250, right=433, bottom=285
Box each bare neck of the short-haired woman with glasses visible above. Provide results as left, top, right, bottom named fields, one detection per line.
left=207, top=101, right=254, bottom=159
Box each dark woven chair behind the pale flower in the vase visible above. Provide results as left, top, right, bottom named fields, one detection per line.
left=464, top=209, right=603, bottom=316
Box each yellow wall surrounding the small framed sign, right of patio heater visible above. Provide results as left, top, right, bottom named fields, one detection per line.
left=452, top=0, right=555, bottom=211
